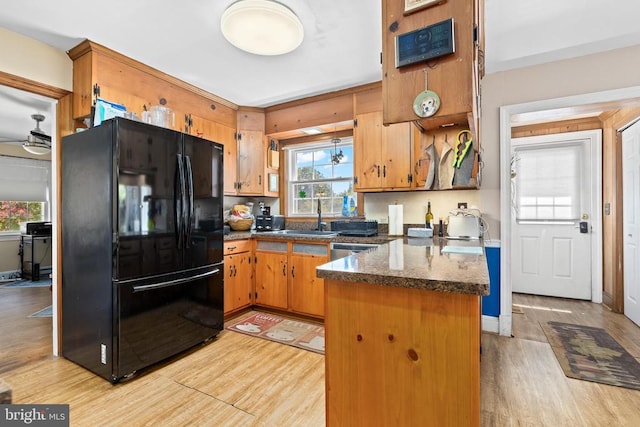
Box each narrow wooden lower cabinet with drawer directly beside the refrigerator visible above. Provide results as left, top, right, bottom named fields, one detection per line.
left=224, top=240, right=253, bottom=315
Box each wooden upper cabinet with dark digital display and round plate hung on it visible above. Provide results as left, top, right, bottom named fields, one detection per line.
left=382, top=0, right=484, bottom=129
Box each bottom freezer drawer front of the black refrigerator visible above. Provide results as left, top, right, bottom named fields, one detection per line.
left=112, top=264, right=224, bottom=382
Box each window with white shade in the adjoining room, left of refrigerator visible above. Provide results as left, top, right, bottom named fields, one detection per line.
left=0, top=156, right=51, bottom=234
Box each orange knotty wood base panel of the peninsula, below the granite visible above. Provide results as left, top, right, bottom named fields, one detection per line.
left=324, top=279, right=480, bottom=427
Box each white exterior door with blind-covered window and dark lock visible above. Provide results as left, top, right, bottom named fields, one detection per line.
left=511, top=131, right=601, bottom=300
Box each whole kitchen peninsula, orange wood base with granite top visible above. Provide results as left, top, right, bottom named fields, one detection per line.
left=317, top=239, right=489, bottom=426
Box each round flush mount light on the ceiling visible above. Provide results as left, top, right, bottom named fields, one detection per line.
left=220, top=0, right=304, bottom=55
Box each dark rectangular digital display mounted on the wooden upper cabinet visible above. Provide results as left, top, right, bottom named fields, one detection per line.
left=396, top=18, right=456, bottom=68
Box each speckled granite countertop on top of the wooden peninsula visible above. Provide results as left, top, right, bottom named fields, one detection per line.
left=316, top=237, right=489, bottom=296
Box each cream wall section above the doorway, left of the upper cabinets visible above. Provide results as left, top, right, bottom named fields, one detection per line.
left=0, top=28, right=73, bottom=91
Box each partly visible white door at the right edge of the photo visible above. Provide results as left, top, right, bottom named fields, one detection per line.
left=622, top=118, right=640, bottom=325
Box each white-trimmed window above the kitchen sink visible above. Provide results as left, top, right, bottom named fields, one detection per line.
left=285, top=137, right=356, bottom=216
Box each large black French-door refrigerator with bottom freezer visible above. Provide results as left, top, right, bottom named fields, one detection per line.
left=62, top=118, right=224, bottom=383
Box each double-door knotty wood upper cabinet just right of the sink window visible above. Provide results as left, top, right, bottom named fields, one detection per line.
left=353, top=111, right=412, bottom=191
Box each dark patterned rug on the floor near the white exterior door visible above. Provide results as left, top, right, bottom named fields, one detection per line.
left=540, top=322, right=640, bottom=390
